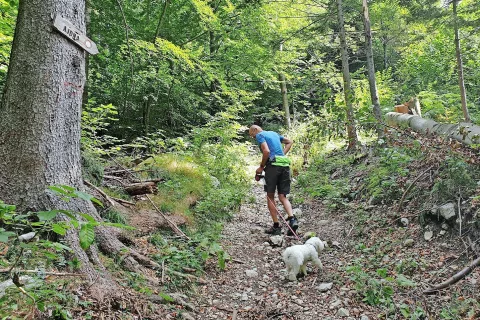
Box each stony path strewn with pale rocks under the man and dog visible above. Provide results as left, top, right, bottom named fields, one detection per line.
left=195, top=181, right=372, bottom=320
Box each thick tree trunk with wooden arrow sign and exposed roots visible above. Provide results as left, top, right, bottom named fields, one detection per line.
left=0, top=0, right=157, bottom=288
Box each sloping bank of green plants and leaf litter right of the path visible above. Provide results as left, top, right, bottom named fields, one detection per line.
left=296, top=138, right=480, bottom=319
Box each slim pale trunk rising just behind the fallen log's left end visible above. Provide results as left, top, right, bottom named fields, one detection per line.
left=363, top=0, right=383, bottom=138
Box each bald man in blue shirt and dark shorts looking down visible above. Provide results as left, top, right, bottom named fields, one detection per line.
left=248, top=125, right=298, bottom=235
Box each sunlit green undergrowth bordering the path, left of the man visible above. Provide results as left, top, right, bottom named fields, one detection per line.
left=108, top=114, right=251, bottom=293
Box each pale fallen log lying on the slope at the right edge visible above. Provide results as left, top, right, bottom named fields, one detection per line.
left=385, top=112, right=480, bottom=145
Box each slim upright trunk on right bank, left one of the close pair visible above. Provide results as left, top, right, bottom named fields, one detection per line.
left=337, top=0, right=358, bottom=150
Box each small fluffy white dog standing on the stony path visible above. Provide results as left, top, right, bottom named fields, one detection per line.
left=283, top=237, right=326, bottom=281
